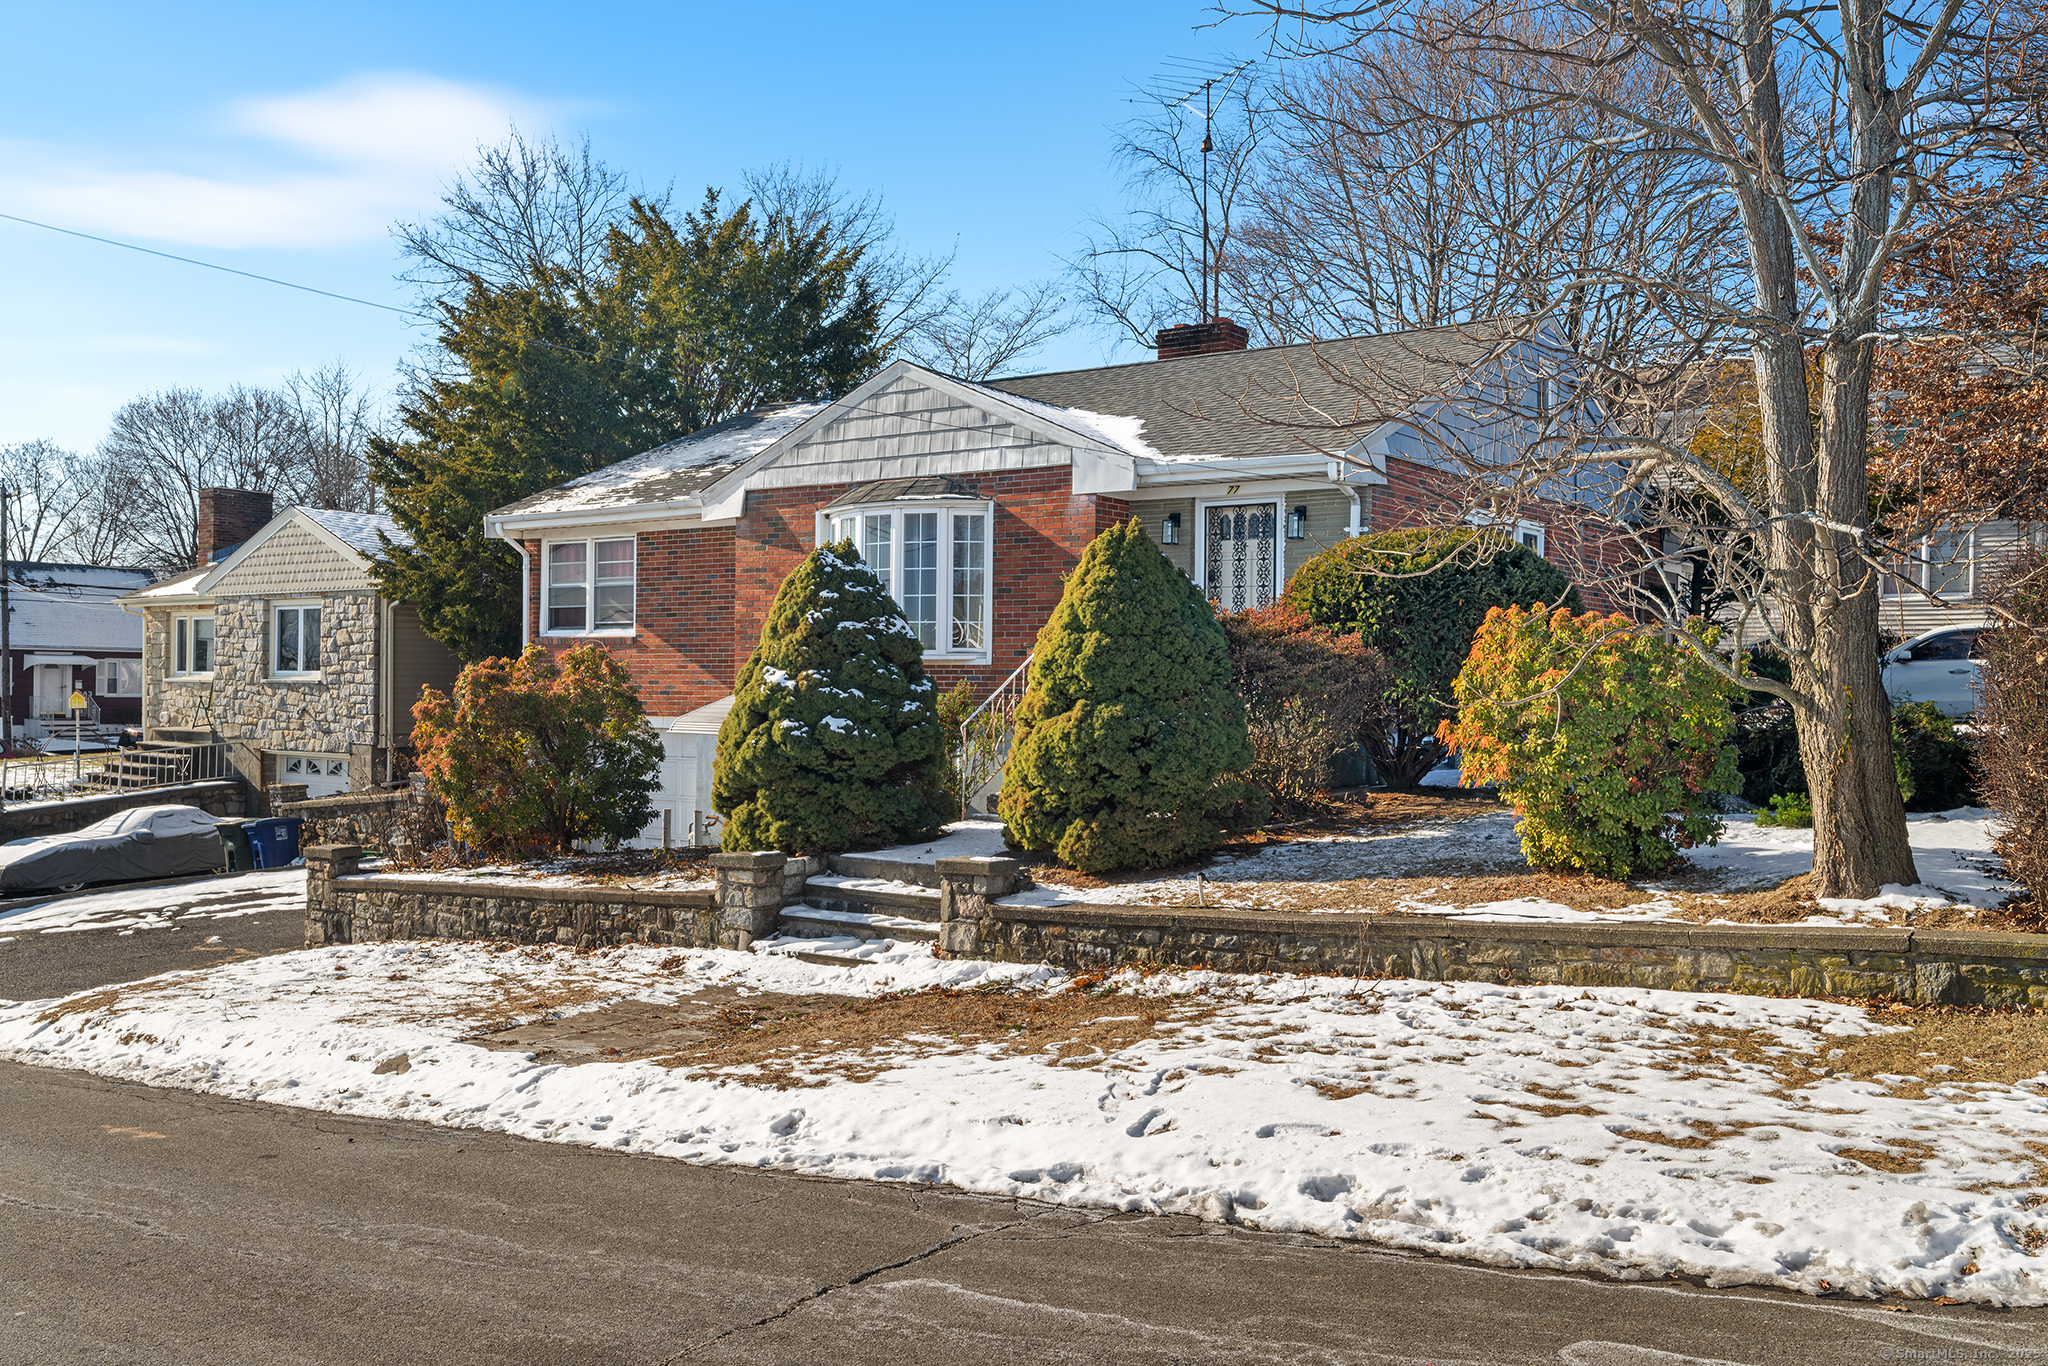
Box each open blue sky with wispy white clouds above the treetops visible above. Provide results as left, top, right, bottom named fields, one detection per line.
left=0, top=0, right=1262, bottom=449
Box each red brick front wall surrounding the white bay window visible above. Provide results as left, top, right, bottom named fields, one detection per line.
left=526, top=465, right=1130, bottom=717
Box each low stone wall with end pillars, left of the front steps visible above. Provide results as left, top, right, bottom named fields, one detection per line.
left=305, top=844, right=823, bottom=950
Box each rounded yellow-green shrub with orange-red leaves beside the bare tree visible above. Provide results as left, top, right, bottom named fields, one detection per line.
left=1442, top=602, right=1741, bottom=877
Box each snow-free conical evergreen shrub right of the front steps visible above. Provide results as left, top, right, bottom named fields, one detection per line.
left=999, top=518, right=1266, bottom=872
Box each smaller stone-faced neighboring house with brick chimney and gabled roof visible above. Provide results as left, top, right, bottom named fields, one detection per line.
left=121, top=489, right=461, bottom=797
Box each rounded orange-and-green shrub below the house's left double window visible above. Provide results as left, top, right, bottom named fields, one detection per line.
left=412, top=643, right=662, bottom=852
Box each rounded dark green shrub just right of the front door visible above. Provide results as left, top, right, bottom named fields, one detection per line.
left=1286, top=526, right=1585, bottom=788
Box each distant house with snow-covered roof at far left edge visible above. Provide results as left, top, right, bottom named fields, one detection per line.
left=6, top=559, right=150, bottom=739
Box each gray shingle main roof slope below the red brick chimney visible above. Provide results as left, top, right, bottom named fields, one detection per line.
left=983, top=319, right=1526, bottom=455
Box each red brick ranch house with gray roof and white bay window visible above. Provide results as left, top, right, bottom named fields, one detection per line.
left=485, top=319, right=1622, bottom=842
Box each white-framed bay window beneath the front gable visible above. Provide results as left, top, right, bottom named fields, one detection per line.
left=819, top=504, right=991, bottom=655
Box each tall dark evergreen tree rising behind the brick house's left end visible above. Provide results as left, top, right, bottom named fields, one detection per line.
left=369, top=193, right=881, bottom=659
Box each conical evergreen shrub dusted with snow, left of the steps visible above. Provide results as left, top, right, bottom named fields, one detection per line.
left=711, top=541, right=948, bottom=854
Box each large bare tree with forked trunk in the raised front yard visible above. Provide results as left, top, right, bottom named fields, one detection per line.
left=1228, top=0, right=2048, bottom=897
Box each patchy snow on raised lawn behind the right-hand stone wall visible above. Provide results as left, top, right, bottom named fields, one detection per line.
left=1004, top=807, right=2011, bottom=926
